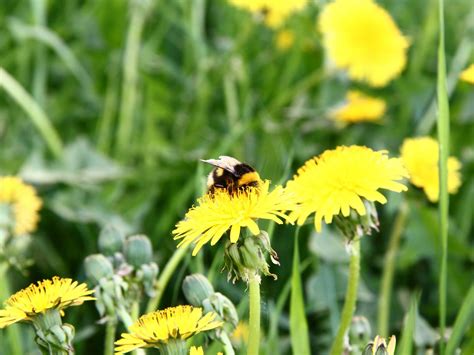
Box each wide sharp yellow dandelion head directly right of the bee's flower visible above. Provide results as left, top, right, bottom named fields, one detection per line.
left=287, top=145, right=408, bottom=232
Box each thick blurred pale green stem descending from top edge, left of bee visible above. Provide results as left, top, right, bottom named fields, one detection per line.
left=117, top=0, right=147, bottom=154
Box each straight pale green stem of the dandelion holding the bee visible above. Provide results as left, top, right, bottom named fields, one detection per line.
left=247, top=273, right=260, bottom=355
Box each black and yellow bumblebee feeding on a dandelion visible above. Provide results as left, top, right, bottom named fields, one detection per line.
left=201, top=155, right=262, bottom=194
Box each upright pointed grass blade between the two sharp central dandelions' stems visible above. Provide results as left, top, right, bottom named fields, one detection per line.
left=290, top=227, right=311, bottom=355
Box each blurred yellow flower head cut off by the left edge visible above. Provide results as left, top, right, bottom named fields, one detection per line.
left=0, top=176, right=42, bottom=235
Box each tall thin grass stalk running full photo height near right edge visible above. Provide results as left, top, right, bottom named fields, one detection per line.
left=437, top=0, right=449, bottom=354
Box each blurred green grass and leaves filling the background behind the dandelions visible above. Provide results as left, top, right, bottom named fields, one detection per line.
left=0, top=0, right=474, bottom=354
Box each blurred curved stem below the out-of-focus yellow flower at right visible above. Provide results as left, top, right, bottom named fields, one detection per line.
left=377, top=201, right=408, bottom=338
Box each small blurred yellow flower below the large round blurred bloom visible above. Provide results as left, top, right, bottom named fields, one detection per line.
left=330, top=91, right=386, bottom=123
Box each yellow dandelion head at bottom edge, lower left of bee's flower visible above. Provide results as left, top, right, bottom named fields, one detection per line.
left=115, top=306, right=223, bottom=353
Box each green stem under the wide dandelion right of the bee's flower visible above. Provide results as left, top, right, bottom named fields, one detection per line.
left=331, top=237, right=360, bottom=355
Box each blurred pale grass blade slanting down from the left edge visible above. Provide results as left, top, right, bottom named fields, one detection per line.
left=0, top=67, right=63, bottom=158
